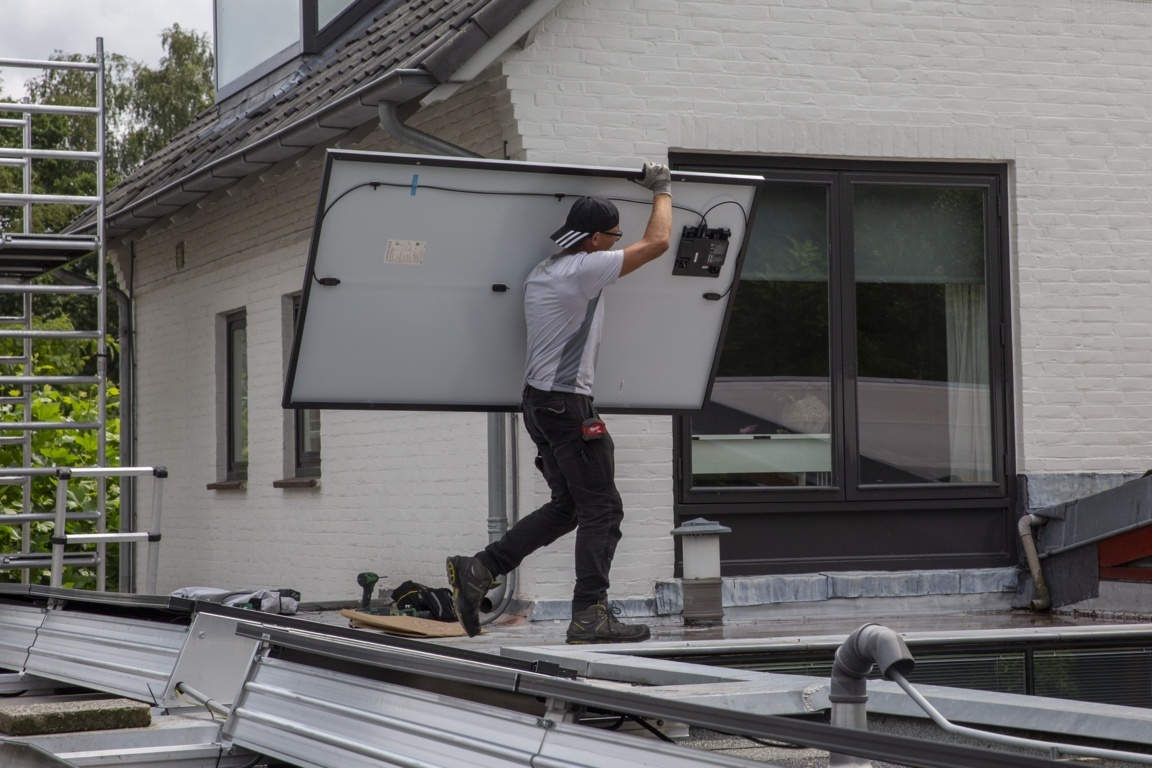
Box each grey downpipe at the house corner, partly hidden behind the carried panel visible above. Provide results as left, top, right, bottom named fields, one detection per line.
left=378, top=101, right=516, bottom=624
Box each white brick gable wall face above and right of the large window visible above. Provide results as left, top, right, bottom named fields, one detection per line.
left=505, top=0, right=1152, bottom=473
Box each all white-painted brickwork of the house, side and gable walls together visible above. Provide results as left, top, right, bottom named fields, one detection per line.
left=119, top=0, right=1152, bottom=600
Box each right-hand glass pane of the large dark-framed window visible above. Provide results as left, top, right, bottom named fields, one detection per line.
left=852, top=184, right=994, bottom=485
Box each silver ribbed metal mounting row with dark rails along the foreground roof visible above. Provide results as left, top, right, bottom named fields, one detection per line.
left=0, top=585, right=1062, bottom=768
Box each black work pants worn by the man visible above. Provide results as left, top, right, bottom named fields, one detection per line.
left=477, top=387, right=624, bottom=613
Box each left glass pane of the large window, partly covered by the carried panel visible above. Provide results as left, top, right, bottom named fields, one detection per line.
left=691, top=183, right=833, bottom=487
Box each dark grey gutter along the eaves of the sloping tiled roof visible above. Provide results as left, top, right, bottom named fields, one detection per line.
left=107, top=69, right=440, bottom=237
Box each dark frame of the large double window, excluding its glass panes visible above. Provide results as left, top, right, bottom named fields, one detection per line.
left=670, top=153, right=1015, bottom=515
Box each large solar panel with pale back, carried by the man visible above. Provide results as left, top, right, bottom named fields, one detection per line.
left=283, top=151, right=760, bottom=412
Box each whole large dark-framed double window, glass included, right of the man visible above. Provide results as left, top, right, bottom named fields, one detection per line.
left=677, top=162, right=1008, bottom=511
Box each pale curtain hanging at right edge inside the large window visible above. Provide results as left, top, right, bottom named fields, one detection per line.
left=945, top=283, right=995, bottom=482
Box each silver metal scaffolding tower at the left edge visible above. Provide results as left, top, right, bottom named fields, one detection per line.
left=0, top=38, right=148, bottom=591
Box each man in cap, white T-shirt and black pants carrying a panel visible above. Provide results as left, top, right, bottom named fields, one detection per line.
left=447, top=162, right=672, bottom=644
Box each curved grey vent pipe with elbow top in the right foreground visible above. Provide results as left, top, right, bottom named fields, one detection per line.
left=828, top=624, right=916, bottom=768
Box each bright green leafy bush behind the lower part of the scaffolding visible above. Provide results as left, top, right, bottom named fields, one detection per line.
left=0, top=318, right=120, bottom=591
